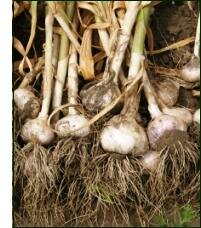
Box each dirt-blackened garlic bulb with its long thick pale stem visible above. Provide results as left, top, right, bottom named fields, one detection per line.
left=80, top=2, right=140, bottom=111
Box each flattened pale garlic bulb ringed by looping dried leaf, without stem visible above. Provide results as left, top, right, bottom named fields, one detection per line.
left=55, top=114, right=90, bottom=137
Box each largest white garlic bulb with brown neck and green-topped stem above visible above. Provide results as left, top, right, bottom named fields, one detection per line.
left=100, top=7, right=150, bottom=155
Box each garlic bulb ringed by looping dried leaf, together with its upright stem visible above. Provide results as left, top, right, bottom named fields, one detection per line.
left=55, top=17, right=90, bottom=137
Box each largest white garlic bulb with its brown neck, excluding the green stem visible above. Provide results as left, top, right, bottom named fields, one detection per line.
left=100, top=74, right=149, bottom=155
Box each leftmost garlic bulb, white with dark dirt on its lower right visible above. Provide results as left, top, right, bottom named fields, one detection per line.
left=14, top=88, right=40, bottom=119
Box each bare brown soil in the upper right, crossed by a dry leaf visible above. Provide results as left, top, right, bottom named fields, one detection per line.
left=151, top=1, right=198, bottom=68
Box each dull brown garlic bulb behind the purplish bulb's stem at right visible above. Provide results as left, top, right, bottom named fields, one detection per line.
left=152, top=79, right=179, bottom=107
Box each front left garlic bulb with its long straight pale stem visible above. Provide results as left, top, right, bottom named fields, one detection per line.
left=21, top=6, right=54, bottom=145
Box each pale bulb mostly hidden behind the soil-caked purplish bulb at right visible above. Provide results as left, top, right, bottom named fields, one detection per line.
left=163, top=107, right=193, bottom=126
